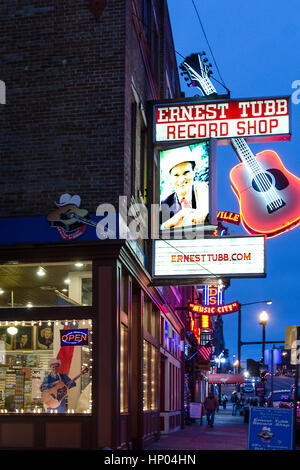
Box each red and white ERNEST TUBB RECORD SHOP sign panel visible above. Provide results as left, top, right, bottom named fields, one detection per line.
left=154, top=97, right=290, bottom=142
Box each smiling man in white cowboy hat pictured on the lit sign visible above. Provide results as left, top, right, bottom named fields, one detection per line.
left=161, top=147, right=209, bottom=229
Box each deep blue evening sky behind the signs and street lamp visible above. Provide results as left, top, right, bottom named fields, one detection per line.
left=168, top=0, right=300, bottom=366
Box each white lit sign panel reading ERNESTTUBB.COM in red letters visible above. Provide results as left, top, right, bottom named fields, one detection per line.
left=153, top=236, right=265, bottom=279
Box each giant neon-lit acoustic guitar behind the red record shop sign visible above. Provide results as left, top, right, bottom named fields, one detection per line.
left=180, top=53, right=300, bottom=238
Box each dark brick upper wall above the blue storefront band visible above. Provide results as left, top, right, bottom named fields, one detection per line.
left=0, top=0, right=180, bottom=217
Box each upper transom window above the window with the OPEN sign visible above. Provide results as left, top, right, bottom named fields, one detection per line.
left=0, top=261, right=92, bottom=308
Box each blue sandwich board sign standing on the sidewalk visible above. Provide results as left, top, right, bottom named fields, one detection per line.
left=248, top=407, right=293, bottom=450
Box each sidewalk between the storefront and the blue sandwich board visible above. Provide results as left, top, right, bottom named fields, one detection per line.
left=146, top=408, right=248, bottom=450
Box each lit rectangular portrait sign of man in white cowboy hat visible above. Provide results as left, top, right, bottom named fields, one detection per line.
left=160, top=142, right=209, bottom=229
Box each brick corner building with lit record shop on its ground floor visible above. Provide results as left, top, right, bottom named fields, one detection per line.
left=0, top=0, right=195, bottom=449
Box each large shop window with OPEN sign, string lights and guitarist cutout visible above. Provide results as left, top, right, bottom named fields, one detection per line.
left=0, top=320, right=92, bottom=415
